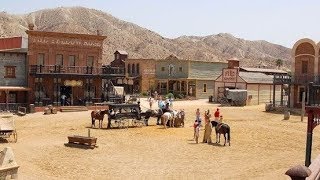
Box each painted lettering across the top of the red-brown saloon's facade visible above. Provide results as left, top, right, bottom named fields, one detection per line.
left=30, top=37, right=102, bottom=47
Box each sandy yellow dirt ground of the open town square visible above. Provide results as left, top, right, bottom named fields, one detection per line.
left=0, top=99, right=320, bottom=180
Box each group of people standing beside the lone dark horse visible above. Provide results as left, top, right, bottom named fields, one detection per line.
left=193, top=108, right=223, bottom=143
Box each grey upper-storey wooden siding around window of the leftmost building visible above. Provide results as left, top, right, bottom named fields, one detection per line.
left=0, top=52, right=27, bottom=86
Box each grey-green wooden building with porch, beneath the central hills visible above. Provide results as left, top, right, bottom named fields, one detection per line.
left=155, top=57, right=227, bottom=98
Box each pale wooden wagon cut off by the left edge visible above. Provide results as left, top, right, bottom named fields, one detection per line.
left=0, top=119, right=18, bottom=142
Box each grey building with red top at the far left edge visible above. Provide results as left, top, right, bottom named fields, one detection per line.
left=0, top=37, right=30, bottom=110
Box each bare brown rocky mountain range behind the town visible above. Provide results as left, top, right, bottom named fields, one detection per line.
left=0, top=7, right=290, bottom=68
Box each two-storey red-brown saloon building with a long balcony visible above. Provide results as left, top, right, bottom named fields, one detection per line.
left=26, top=25, right=124, bottom=106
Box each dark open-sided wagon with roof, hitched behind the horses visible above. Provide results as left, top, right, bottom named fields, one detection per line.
left=107, top=104, right=145, bottom=129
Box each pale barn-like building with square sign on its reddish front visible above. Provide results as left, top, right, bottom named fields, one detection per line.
left=214, top=58, right=287, bottom=105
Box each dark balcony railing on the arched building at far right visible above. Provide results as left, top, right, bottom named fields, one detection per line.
left=273, top=75, right=320, bottom=85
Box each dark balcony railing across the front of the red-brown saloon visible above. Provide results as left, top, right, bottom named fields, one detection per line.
left=29, top=65, right=124, bottom=75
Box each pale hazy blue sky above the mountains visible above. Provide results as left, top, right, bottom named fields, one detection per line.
left=0, top=0, right=320, bottom=48
